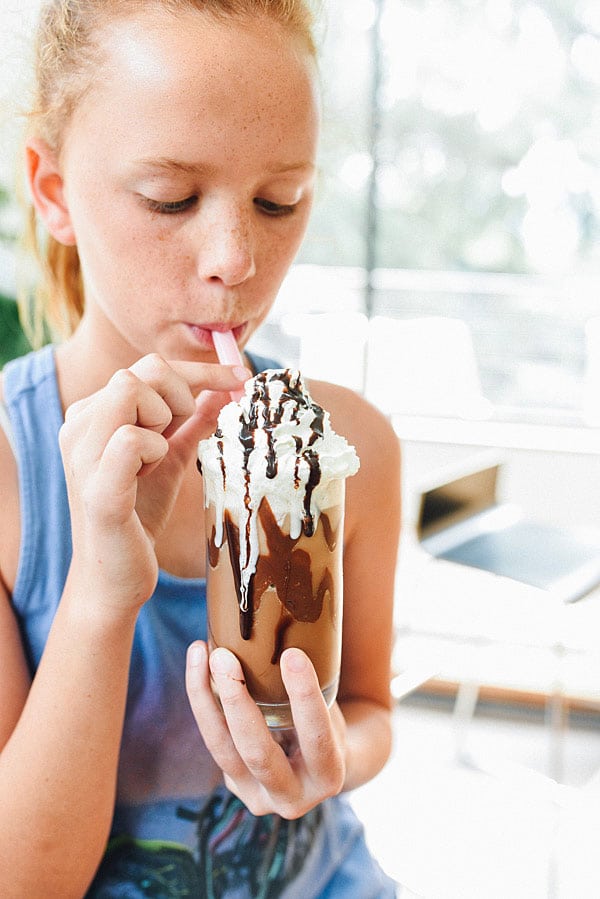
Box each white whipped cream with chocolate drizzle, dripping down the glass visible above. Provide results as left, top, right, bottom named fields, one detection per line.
left=198, top=369, right=360, bottom=610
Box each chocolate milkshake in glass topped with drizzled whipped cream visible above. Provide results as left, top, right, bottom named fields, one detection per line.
left=198, top=369, right=359, bottom=729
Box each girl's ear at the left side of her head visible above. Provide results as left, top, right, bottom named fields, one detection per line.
left=25, top=138, right=76, bottom=246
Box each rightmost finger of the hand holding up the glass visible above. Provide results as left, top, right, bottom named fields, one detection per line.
left=280, top=648, right=345, bottom=793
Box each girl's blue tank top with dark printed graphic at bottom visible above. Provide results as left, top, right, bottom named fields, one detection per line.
left=4, top=346, right=394, bottom=899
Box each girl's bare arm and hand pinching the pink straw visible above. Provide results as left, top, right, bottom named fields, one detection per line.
left=0, top=359, right=248, bottom=899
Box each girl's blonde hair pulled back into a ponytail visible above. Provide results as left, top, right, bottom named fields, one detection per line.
left=21, top=0, right=318, bottom=345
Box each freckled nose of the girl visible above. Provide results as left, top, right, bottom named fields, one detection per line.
left=197, top=204, right=256, bottom=287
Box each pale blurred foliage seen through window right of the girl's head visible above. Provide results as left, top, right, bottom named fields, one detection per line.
left=301, top=0, right=600, bottom=274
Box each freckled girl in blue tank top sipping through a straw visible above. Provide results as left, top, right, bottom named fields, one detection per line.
left=0, top=0, right=399, bottom=899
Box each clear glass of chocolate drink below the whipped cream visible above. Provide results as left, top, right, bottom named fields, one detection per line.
left=205, top=479, right=345, bottom=736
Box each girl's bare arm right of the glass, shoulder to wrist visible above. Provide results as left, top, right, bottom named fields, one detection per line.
left=326, top=388, right=401, bottom=789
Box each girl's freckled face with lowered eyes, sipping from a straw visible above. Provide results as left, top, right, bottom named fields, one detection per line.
left=61, top=11, right=318, bottom=364
